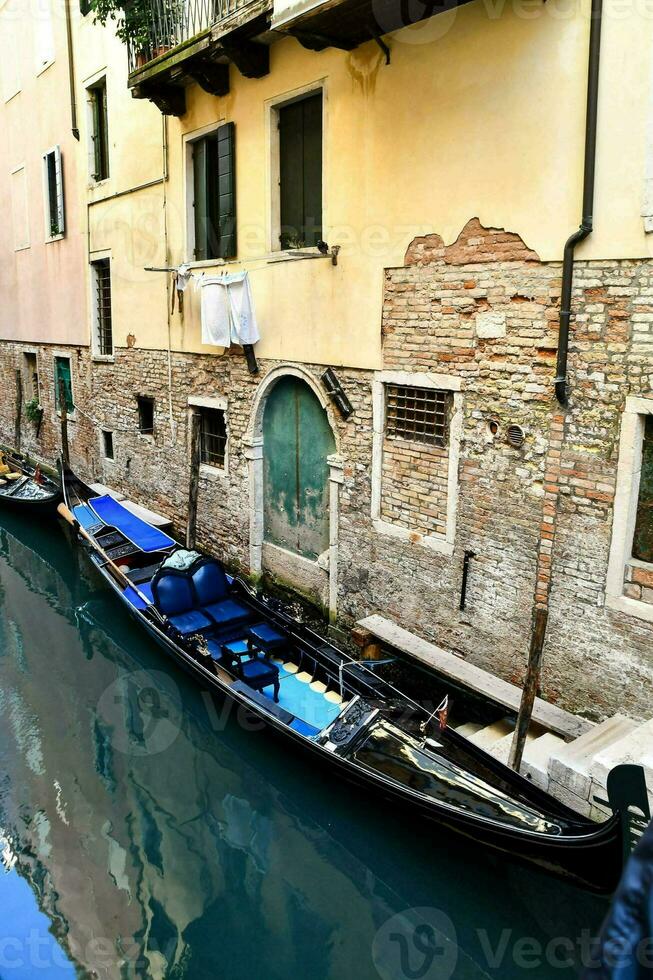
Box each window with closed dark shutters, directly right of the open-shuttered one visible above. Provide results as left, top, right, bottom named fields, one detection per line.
left=278, top=92, right=322, bottom=248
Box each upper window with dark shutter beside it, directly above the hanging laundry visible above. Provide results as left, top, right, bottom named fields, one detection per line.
left=191, top=123, right=236, bottom=262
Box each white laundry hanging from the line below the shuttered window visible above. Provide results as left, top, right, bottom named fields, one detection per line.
left=198, top=272, right=260, bottom=347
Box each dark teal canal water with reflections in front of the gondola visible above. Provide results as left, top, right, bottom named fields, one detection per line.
left=0, top=515, right=606, bottom=980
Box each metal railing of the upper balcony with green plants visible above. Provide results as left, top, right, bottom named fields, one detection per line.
left=125, top=0, right=253, bottom=72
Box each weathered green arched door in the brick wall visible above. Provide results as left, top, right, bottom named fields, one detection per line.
left=263, top=377, right=335, bottom=559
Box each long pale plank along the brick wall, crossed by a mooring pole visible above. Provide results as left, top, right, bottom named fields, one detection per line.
left=358, top=616, right=593, bottom=738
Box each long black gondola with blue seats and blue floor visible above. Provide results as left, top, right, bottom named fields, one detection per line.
left=59, top=470, right=647, bottom=892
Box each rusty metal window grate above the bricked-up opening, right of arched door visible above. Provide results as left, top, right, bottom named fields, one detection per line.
left=386, top=385, right=451, bottom=446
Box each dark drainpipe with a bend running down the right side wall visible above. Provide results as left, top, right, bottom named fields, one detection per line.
left=554, top=0, right=603, bottom=405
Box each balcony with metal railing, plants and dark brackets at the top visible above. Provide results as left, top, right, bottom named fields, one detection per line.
left=125, top=0, right=272, bottom=116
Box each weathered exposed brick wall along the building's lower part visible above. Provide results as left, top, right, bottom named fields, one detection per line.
left=0, top=222, right=653, bottom=717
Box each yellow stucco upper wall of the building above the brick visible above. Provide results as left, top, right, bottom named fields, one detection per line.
left=0, top=0, right=651, bottom=367
